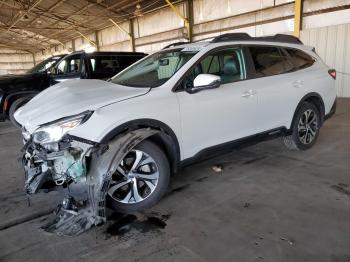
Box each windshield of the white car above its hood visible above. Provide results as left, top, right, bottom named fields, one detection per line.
left=111, top=49, right=197, bottom=87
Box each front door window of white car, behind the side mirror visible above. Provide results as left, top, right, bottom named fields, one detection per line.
left=182, top=48, right=246, bottom=89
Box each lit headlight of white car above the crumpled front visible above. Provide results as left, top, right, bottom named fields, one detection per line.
left=33, top=111, right=93, bottom=144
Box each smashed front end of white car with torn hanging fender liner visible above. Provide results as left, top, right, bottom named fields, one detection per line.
left=22, top=112, right=158, bottom=235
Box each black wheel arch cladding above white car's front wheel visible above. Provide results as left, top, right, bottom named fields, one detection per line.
left=100, top=118, right=180, bottom=173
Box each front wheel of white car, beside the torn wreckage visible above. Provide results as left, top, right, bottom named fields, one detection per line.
left=106, top=140, right=170, bottom=213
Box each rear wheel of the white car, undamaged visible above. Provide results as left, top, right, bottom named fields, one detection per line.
left=283, top=102, right=321, bottom=150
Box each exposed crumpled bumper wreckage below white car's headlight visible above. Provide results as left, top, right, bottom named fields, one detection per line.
left=22, top=137, right=94, bottom=194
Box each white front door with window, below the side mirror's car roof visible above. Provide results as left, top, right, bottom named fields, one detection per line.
left=177, top=47, right=257, bottom=158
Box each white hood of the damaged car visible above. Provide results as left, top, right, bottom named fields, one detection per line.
left=15, top=79, right=149, bottom=132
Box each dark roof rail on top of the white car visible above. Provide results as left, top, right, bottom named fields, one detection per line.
left=211, top=33, right=303, bottom=45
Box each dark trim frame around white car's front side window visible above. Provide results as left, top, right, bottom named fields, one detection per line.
left=171, top=44, right=254, bottom=93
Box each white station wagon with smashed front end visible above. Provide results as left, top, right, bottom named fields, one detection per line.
left=15, top=34, right=336, bottom=212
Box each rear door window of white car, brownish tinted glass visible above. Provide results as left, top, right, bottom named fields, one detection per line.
left=249, top=46, right=294, bottom=77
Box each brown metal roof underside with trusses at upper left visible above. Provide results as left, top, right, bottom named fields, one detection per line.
left=0, top=0, right=166, bottom=52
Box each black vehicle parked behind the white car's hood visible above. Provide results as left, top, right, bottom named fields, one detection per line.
left=0, top=52, right=146, bottom=126
